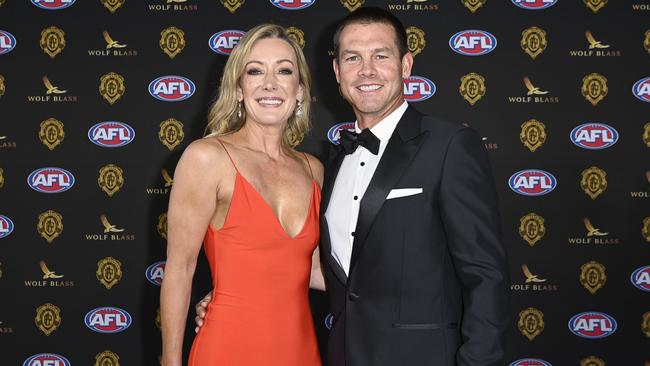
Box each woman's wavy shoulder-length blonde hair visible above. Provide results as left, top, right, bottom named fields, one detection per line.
left=205, top=24, right=311, bottom=148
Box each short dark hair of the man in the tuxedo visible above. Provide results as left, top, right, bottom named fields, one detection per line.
left=333, top=6, right=408, bottom=59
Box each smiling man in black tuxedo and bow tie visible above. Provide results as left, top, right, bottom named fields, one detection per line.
left=195, top=7, right=509, bottom=366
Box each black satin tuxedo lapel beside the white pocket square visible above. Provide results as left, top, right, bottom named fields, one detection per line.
left=350, top=106, right=426, bottom=273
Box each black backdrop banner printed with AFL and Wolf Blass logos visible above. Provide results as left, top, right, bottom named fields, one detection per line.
left=0, top=0, right=650, bottom=366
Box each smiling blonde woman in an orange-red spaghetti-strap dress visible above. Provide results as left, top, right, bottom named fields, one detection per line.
left=160, top=25, right=324, bottom=366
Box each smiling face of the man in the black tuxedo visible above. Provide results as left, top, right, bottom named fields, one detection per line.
left=333, top=23, right=413, bottom=121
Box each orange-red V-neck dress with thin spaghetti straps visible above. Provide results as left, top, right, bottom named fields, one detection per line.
left=188, top=147, right=321, bottom=366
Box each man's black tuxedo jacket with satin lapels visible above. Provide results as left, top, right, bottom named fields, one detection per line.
left=320, top=106, right=509, bottom=366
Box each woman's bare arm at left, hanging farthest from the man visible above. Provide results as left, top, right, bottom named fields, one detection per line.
left=160, top=140, right=217, bottom=366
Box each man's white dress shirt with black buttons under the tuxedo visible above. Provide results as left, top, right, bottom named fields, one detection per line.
left=325, top=101, right=408, bottom=275
